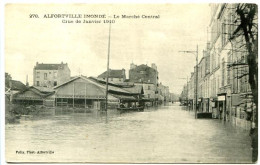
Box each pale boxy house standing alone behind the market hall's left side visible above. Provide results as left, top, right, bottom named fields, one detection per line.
left=33, top=62, right=70, bottom=87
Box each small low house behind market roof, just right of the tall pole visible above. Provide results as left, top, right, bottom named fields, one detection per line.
left=97, top=69, right=126, bottom=84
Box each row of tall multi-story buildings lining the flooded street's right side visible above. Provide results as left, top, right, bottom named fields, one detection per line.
left=181, top=4, right=255, bottom=129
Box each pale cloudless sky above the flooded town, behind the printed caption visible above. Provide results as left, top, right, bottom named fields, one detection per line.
left=4, top=4, right=210, bottom=94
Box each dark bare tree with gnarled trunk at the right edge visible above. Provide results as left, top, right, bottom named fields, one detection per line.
left=231, top=3, right=258, bottom=162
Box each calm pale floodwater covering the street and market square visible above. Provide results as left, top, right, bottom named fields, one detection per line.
left=6, top=104, right=251, bottom=163
